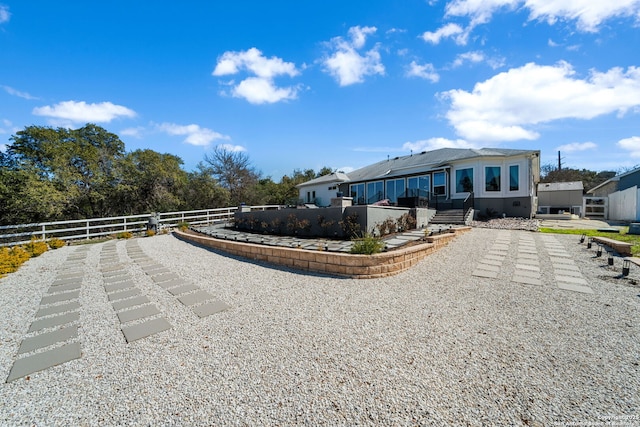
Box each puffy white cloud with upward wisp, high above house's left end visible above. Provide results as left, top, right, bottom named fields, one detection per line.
left=323, top=27, right=385, bottom=86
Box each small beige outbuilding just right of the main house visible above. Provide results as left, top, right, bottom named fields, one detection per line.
left=538, top=181, right=584, bottom=215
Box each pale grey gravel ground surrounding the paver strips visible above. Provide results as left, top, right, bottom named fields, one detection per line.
left=0, top=229, right=640, bottom=426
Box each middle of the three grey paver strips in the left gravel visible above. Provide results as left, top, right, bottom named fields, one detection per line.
left=100, top=242, right=171, bottom=343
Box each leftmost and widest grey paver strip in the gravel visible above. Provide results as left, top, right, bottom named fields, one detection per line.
left=6, top=246, right=89, bottom=382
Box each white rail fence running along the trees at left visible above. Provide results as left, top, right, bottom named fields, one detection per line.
left=0, top=205, right=281, bottom=246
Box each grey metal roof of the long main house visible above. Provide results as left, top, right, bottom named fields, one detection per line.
left=349, top=148, right=540, bottom=182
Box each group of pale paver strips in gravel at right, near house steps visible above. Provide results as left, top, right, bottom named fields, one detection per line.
left=472, top=231, right=593, bottom=294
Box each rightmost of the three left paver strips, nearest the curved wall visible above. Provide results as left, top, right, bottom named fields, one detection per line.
left=127, top=241, right=229, bottom=320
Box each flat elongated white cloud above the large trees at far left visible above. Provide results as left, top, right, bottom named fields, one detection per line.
left=32, top=101, right=136, bottom=123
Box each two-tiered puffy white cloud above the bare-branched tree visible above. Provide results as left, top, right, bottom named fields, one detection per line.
left=211, top=47, right=300, bottom=104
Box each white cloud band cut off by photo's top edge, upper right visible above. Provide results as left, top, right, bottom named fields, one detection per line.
left=446, top=0, right=640, bottom=32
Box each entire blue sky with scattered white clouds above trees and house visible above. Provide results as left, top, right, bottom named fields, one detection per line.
left=0, top=0, right=640, bottom=181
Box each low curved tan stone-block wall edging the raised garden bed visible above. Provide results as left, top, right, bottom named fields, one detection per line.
left=173, top=227, right=471, bottom=279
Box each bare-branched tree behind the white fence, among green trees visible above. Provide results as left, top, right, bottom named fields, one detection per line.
left=204, top=146, right=260, bottom=205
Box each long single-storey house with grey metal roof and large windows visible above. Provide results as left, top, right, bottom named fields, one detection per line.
left=298, top=148, right=540, bottom=218
